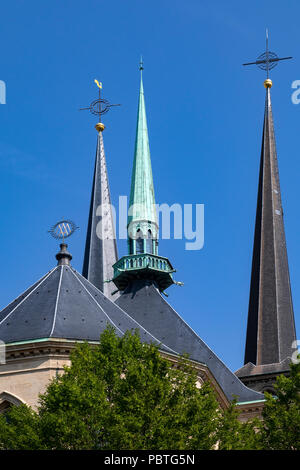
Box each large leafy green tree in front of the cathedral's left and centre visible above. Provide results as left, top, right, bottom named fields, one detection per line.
left=0, top=328, right=254, bottom=450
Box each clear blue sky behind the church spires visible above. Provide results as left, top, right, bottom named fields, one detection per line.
left=0, top=0, right=300, bottom=370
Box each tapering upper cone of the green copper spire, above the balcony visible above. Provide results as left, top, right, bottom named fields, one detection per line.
left=128, top=64, right=157, bottom=248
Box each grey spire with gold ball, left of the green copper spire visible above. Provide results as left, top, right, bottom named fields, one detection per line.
left=82, top=129, right=118, bottom=300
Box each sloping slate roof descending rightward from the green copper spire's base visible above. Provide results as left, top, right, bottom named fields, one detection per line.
left=116, top=280, right=264, bottom=402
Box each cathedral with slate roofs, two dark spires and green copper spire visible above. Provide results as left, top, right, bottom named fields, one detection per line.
left=0, top=54, right=296, bottom=420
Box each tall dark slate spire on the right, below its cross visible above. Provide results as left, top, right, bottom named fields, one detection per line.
left=244, top=80, right=296, bottom=368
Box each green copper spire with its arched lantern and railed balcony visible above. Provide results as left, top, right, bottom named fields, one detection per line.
left=113, top=63, right=177, bottom=292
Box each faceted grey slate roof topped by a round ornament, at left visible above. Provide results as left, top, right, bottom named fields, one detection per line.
left=0, top=253, right=175, bottom=353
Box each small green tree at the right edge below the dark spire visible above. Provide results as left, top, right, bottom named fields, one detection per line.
left=261, top=356, right=300, bottom=450
